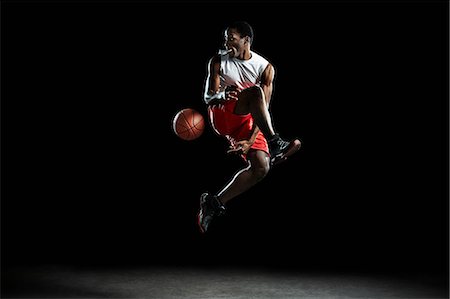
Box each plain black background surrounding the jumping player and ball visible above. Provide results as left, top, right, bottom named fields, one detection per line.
left=1, top=1, right=449, bottom=276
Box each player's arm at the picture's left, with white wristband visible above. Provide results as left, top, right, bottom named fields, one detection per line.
left=203, top=55, right=225, bottom=105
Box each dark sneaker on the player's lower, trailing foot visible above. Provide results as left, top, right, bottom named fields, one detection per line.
left=197, top=193, right=226, bottom=233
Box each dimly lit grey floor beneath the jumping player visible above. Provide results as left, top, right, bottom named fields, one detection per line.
left=2, top=265, right=449, bottom=299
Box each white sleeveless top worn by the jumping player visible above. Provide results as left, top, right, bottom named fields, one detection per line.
left=220, top=51, right=269, bottom=91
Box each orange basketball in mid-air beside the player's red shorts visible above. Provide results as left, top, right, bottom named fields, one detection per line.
left=173, top=108, right=205, bottom=140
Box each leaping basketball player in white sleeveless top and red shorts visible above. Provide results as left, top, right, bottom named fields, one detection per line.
left=198, top=21, right=301, bottom=233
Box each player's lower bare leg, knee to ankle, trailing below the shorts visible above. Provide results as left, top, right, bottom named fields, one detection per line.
left=217, top=150, right=270, bottom=204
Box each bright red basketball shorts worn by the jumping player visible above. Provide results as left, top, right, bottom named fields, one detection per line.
left=208, top=100, right=269, bottom=158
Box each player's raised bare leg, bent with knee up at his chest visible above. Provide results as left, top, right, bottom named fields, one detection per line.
left=234, top=86, right=275, bottom=139
